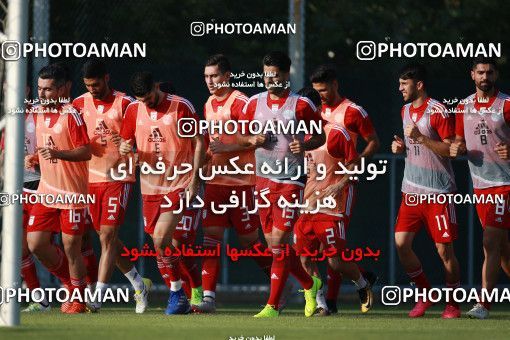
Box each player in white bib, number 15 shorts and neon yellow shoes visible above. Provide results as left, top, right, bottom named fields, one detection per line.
left=240, top=52, right=325, bottom=317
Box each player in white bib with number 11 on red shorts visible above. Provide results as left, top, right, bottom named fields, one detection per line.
left=391, top=64, right=460, bottom=319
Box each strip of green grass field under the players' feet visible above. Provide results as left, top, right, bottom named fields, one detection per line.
left=0, top=305, right=510, bottom=340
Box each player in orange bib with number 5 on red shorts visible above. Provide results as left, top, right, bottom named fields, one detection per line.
left=73, top=59, right=152, bottom=313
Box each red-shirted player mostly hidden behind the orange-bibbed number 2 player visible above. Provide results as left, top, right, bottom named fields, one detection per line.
left=310, top=65, right=380, bottom=314
